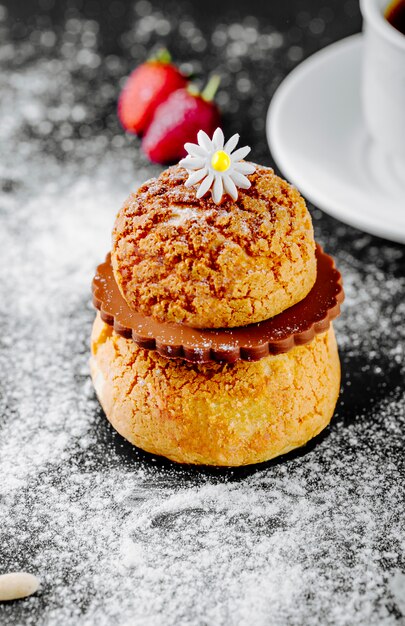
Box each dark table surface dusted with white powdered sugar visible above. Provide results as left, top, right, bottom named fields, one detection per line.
left=0, top=0, right=405, bottom=626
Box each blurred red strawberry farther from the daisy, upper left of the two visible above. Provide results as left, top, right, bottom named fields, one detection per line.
left=118, top=50, right=188, bottom=135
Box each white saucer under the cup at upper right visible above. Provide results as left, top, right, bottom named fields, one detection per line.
left=267, top=35, right=405, bottom=243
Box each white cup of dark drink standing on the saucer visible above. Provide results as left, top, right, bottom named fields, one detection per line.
left=360, top=0, right=405, bottom=162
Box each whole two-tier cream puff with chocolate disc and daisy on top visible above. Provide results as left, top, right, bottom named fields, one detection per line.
left=91, top=130, right=343, bottom=466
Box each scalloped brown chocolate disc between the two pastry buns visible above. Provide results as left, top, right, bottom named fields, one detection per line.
left=92, top=245, right=344, bottom=363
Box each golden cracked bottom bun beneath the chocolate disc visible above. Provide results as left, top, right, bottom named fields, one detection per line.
left=91, top=314, right=340, bottom=466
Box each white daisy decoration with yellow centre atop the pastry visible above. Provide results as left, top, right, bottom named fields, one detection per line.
left=179, top=128, right=256, bottom=204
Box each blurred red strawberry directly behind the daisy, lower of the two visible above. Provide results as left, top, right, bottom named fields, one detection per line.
left=142, top=76, right=221, bottom=164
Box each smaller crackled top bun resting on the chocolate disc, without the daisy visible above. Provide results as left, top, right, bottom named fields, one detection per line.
left=112, top=166, right=316, bottom=328
